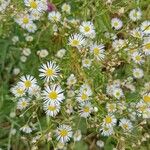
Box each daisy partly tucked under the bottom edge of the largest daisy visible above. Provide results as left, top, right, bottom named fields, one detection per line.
left=44, top=103, right=60, bottom=117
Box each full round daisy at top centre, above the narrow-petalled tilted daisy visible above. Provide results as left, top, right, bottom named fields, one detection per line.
left=79, top=21, right=95, bottom=37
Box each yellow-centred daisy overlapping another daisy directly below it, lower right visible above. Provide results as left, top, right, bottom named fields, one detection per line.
left=102, top=114, right=117, bottom=127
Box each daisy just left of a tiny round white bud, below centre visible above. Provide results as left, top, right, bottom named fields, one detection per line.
left=80, top=102, right=93, bottom=118
